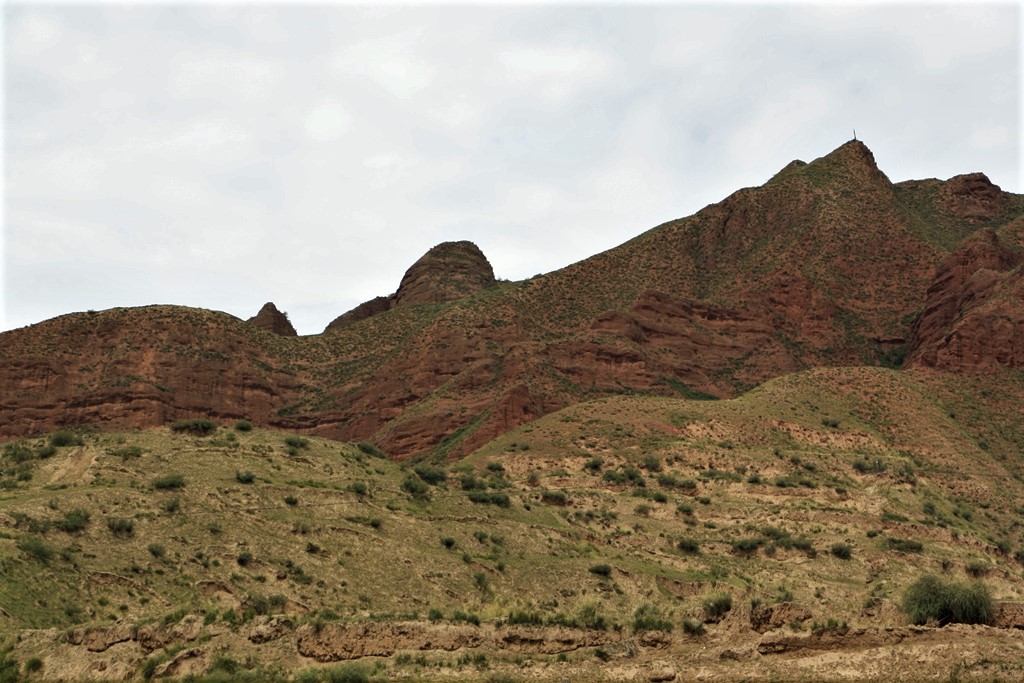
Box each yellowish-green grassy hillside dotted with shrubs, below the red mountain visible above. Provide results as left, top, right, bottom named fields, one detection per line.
left=0, top=369, right=1024, bottom=680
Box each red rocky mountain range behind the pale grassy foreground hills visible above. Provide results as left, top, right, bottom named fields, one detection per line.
left=0, top=140, right=1024, bottom=458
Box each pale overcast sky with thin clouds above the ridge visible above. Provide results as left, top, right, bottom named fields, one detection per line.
left=0, top=2, right=1022, bottom=334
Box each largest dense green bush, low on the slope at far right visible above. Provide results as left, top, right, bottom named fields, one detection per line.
left=902, top=574, right=994, bottom=625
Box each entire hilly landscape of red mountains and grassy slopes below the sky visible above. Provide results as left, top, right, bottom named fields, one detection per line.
left=0, top=141, right=1024, bottom=681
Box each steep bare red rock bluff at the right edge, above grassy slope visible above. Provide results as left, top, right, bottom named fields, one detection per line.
left=909, top=230, right=1024, bottom=371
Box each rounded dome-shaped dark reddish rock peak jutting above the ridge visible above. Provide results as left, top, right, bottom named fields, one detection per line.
left=394, top=241, right=495, bottom=306
